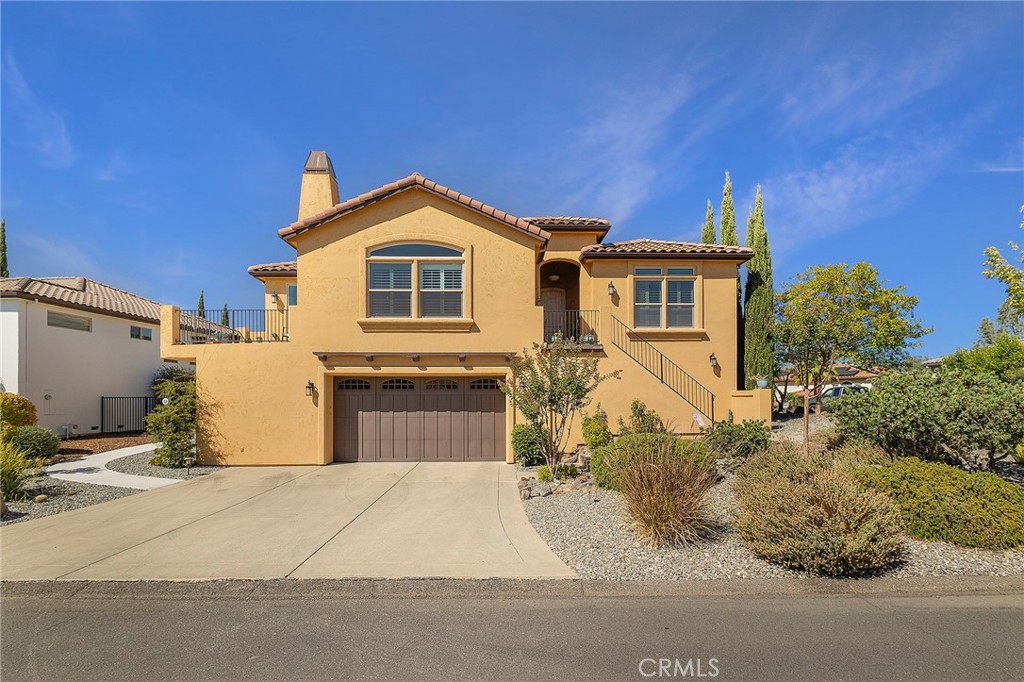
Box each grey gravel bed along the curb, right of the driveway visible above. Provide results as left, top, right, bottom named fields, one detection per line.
left=522, top=478, right=1024, bottom=581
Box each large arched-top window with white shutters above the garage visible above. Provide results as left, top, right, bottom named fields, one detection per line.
left=368, top=244, right=465, bottom=317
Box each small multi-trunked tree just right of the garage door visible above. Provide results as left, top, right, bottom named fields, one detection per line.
left=502, top=339, right=620, bottom=471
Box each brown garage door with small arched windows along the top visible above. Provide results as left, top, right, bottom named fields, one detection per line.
left=334, top=378, right=505, bottom=462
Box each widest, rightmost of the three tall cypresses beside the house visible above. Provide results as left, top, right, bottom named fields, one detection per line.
left=743, top=185, right=775, bottom=389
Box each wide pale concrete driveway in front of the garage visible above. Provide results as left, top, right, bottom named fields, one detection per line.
left=0, top=462, right=574, bottom=580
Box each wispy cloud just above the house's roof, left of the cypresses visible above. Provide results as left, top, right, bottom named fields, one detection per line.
left=565, top=77, right=693, bottom=221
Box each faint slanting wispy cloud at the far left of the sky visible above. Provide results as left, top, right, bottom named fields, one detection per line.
left=2, top=51, right=75, bottom=168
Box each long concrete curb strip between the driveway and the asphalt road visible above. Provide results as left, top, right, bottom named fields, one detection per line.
left=0, top=576, right=1024, bottom=600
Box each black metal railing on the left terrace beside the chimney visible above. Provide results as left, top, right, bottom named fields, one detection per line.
left=178, top=308, right=288, bottom=344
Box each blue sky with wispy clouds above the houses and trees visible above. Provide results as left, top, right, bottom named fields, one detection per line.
left=0, top=2, right=1024, bottom=354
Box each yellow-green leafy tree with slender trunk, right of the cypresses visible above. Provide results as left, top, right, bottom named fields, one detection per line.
left=775, top=262, right=932, bottom=446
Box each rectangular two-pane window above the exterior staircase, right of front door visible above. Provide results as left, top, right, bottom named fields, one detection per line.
left=633, top=267, right=696, bottom=329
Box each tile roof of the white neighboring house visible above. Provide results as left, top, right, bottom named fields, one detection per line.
left=0, top=278, right=160, bottom=325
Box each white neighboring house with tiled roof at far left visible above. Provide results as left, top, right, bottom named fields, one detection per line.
left=0, top=278, right=180, bottom=436
